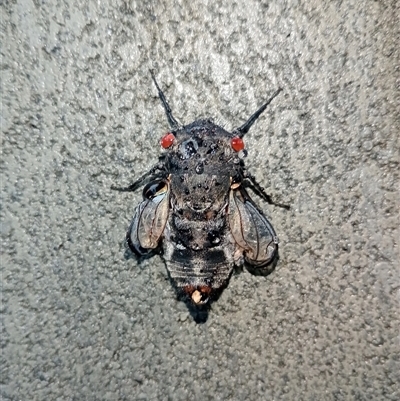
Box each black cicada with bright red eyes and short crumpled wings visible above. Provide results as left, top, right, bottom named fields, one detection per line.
left=114, top=72, right=288, bottom=305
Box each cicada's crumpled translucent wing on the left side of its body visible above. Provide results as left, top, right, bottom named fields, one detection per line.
left=126, top=181, right=170, bottom=255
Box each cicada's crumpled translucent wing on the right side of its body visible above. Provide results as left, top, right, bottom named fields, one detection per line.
left=228, top=187, right=278, bottom=267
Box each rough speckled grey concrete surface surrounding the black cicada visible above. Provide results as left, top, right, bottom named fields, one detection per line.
left=0, top=0, right=400, bottom=401
